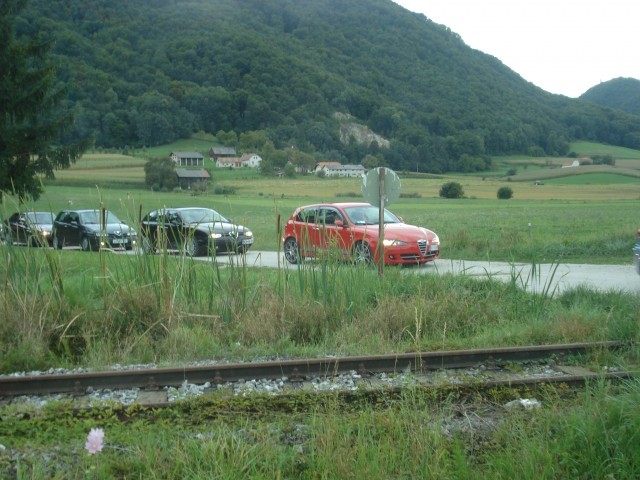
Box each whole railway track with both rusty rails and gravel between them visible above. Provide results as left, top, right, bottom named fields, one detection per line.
left=0, top=342, right=633, bottom=407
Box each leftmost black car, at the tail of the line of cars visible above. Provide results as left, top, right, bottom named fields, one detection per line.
left=3, top=212, right=54, bottom=247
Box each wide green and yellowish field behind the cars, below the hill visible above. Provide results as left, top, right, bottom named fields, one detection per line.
left=0, top=139, right=640, bottom=263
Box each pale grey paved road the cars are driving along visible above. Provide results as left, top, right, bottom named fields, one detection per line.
left=203, top=251, right=640, bottom=293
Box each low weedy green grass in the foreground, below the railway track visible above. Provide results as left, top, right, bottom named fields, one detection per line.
left=0, top=381, right=640, bottom=480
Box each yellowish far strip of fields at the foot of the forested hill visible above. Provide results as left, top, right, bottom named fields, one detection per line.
left=52, top=140, right=640, bottom=202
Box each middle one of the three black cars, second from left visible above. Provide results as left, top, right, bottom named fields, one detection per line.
left=53, top=210, right=138, bottom=252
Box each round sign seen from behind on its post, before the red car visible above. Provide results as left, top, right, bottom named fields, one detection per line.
left=362, top=167, right=401, bottom=276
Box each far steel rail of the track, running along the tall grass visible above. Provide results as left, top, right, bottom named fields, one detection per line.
left=0, top=342, right=628, bottom=397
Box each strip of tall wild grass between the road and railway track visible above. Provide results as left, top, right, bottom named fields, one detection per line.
left=0, top=232, right=640, bottom=372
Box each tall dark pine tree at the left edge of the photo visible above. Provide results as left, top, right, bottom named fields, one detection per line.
left=0, top=0, right=88, bottom=202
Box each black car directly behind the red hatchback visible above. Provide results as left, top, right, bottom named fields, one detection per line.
left=140, top=207, right=253, bottom=257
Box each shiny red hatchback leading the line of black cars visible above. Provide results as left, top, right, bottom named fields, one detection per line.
left=282, top=203, right=440, bottom=265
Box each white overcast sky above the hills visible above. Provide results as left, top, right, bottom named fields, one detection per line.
left=394, top=0, right=640, bottom=97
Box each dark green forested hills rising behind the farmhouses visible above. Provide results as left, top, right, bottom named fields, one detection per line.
left=16, top=0, right=640, bottom=172
